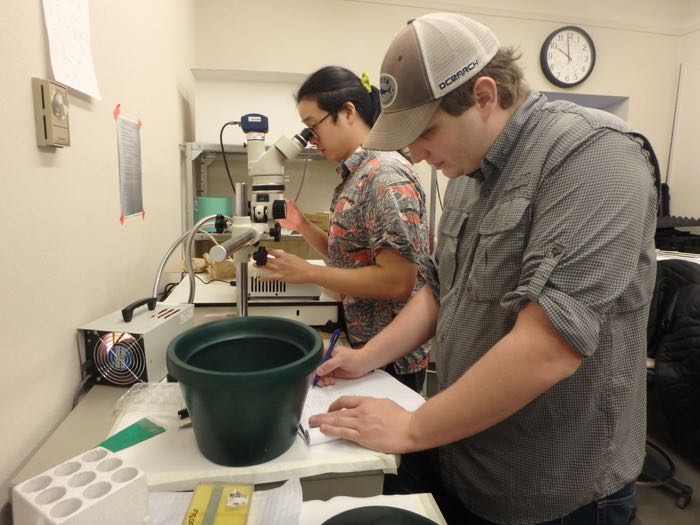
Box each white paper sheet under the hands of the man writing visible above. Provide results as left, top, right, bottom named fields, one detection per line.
left=301, top=370, right=425, bottom=445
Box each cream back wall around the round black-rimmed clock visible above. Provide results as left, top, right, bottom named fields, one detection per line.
left=195, top=0, right=689, bottom=229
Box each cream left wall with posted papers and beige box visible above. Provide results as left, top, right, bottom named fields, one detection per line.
left=0, top=0, right=195, bottom=522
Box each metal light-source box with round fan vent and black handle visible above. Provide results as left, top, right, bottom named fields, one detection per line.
left=78, top=303, right=194, bottom=386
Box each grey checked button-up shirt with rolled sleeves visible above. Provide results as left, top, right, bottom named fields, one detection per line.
left=428, top=93, right=658, bottom=524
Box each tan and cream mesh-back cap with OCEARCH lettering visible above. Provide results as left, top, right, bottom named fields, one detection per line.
left=363, top=13, right=499, bottom=151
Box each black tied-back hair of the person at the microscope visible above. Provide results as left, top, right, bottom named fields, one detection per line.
left=295, top=66, right=382, bottom=128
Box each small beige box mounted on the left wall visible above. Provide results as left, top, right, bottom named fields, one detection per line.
left=32, top=77, right=70, bottom=148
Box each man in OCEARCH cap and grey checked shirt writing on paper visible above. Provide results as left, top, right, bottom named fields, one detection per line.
left=311, top=13, right=659, bottom=525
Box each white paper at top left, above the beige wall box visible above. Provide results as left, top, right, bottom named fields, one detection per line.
left=43, top=0, right=101, bottom=100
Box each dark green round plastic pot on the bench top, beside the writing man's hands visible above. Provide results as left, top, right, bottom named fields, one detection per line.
left=166, top=317, right=323, bottom=467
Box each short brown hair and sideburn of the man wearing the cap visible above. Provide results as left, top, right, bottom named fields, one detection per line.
left=440, top=47, right=530, bottom=117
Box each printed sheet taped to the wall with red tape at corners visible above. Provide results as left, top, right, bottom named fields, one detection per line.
left=116, top=115, right=143, bottom=221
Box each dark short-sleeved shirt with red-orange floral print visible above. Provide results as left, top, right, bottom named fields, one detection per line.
left=328, top=150, right=428, bottom=374
